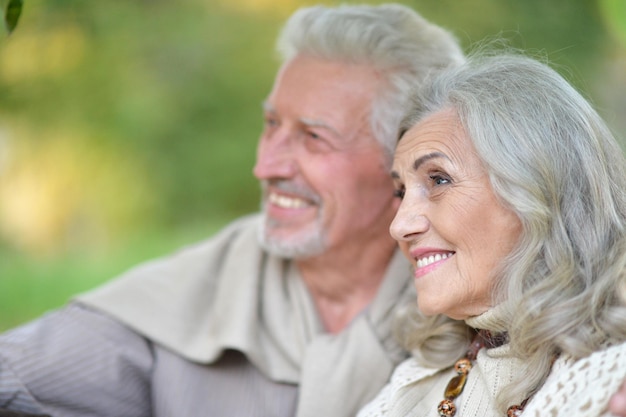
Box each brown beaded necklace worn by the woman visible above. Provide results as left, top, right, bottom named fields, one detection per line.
left=437, top=330, right=528, bottom=417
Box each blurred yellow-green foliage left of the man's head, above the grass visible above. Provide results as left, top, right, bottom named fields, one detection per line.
left=0, top=0, right=276, bottom=255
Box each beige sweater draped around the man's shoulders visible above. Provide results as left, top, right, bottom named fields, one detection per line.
left=78, top=216, right=415, bottom=417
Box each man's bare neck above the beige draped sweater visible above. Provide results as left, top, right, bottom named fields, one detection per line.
left=296, top=239, right=396, bottom=333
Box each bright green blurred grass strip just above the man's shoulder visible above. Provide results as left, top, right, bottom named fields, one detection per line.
left=0, top=220, right=223, bottom=331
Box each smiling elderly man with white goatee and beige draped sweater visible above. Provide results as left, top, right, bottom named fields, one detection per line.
left=0, top=4, right=463, bottom=417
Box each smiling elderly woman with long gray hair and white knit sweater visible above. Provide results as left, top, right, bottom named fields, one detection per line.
left=359, top=55, right=626, bottom=417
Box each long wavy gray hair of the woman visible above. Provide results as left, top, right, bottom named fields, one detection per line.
left=401, top=53, right=626, bottom=410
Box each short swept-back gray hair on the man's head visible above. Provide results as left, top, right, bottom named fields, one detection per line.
left=276, top=4, right=464, bottom=164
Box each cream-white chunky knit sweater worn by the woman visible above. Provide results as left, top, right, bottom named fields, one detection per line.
left=358, top=311, right=626, bottom=417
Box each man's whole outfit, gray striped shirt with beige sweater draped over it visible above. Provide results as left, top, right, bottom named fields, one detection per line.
left=0, top=216, right=415, bottom=417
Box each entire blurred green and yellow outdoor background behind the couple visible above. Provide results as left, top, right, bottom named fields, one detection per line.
left=0, top=0, right=626, bottom=330
